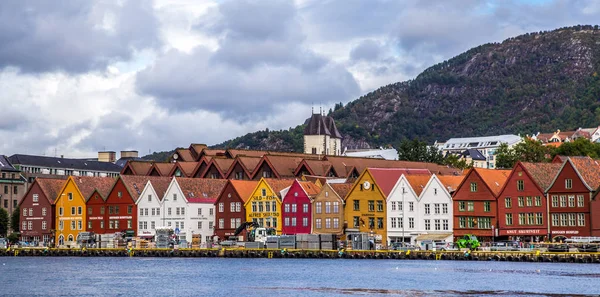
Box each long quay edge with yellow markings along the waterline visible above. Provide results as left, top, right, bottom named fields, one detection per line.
left=0, top=248, right=600, bottom=263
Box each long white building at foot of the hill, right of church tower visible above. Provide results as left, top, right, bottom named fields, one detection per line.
left=435, top=134, right=521, bottom=169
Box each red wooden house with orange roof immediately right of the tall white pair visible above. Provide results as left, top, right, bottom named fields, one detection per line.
left=452, top=168, right=511, bottom=241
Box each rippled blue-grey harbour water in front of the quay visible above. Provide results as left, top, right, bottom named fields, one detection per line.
left=0, top=257, right=600, bottom=296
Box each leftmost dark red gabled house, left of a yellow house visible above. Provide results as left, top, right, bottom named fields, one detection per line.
left=19, top=177, right=65, bottom=244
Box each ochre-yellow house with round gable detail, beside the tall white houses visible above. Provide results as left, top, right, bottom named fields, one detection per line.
left=344, top=168, right=405, bottom=244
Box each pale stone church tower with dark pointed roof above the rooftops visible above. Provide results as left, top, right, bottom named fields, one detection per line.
left=304, top=108, right=342, bottom=156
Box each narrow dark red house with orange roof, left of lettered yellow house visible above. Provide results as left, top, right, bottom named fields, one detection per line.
left=215, top=180, right=258, bottom=241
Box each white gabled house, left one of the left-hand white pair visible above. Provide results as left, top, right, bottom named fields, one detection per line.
left=135, top=177, right=172, bottom=238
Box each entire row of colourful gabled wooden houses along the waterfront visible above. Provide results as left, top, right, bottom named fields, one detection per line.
left=20, top=157, right=600, bottom=245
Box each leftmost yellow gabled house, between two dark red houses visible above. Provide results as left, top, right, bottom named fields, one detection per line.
left=54, top=176, right=115, bottom=246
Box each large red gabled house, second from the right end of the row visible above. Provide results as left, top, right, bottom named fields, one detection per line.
left=498, top=162, right=562, bottom=242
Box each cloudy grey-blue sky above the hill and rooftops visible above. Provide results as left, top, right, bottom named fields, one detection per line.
left=0, top=0, right=600, bottom=157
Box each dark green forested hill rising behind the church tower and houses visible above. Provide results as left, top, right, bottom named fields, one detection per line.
left=217, top=26, right=600, bottom=151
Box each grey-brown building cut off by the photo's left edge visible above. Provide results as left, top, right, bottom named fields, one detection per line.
left=0, top=155, right=27, bottom=215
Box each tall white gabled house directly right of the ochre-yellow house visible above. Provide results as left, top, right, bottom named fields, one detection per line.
left=386, top=174, right=419, bottom=245
